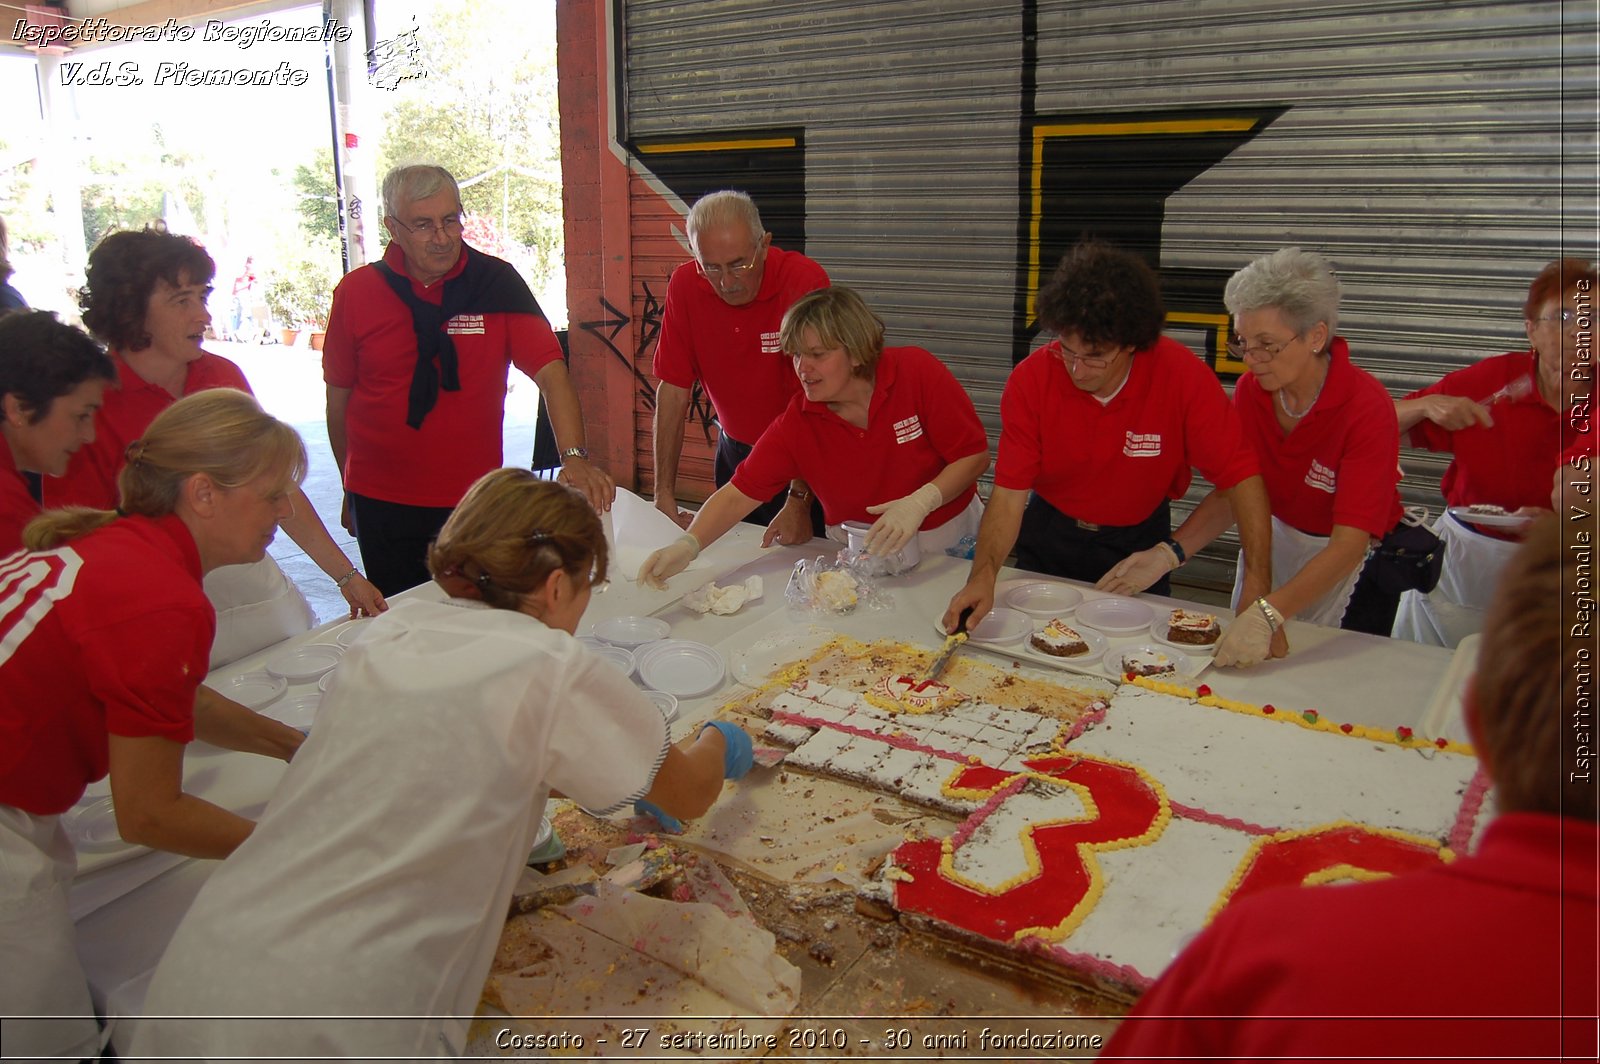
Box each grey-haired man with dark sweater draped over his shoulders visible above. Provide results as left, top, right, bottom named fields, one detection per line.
left=322, top=165, right=616, bottom=595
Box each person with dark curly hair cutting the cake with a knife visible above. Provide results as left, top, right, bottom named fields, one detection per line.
left=944, top=242, right=1272, bottom=646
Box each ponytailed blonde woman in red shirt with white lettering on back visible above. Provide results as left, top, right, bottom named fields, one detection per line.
left=0, top=389, right=306, bottom=1058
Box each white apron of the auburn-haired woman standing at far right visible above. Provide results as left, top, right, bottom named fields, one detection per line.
left=1392, top=510, right=1522, bottom=646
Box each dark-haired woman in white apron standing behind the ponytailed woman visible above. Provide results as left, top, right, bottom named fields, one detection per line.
left=43, top=229, right=387, bottom=666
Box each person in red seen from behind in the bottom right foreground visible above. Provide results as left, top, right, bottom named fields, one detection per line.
left=1099, top=517, right=1600, bottom=1061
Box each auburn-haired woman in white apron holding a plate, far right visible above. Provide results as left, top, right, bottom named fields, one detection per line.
left=1394, top=259, right=1600, bottom=646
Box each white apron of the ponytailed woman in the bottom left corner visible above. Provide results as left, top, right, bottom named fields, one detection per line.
left=0, top=805, right=102, bottom=1059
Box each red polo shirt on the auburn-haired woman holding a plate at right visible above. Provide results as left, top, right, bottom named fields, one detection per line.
left=1406, top=350, right=1563, bottom=510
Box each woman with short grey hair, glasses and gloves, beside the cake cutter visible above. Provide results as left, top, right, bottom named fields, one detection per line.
left=1132, top=248, right=1402, bottom=666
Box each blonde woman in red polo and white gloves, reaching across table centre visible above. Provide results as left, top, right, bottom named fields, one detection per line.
left=638, top=286, right=989, bottom=587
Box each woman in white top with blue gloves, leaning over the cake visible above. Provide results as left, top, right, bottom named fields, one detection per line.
left=133, top=469, right=750, bottom=1059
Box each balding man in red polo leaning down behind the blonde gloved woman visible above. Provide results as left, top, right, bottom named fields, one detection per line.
left=653, top=190, right=827, bottom=544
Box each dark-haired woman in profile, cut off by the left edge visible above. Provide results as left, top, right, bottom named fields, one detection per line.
left=0, top=310, right=117, bottom=555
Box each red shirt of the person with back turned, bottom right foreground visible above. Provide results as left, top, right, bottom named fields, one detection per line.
left=1099, top=813, right=1600, bottom=1061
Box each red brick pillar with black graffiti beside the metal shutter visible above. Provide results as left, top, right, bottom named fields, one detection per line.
left=555, top=0, right=638, bottom=488
